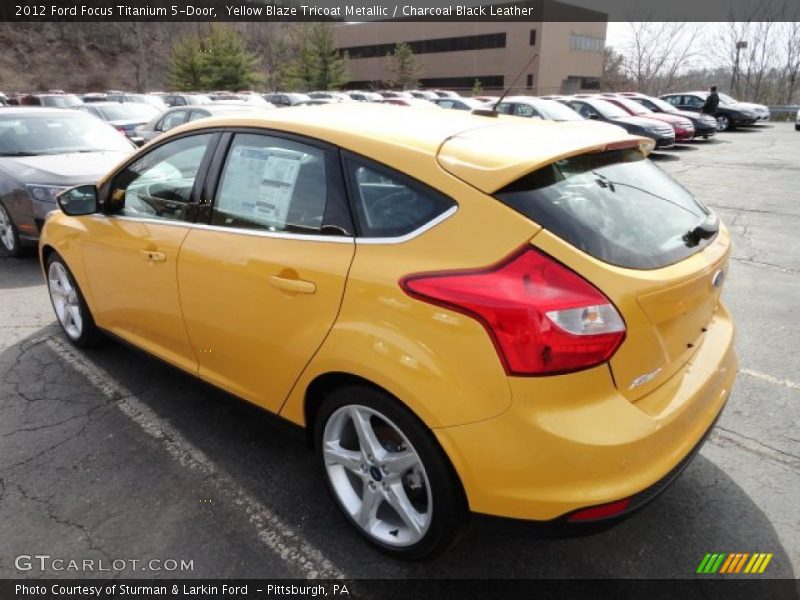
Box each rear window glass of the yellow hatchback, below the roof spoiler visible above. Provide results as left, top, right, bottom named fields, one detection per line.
left=495, top=150, right=713, bottom=269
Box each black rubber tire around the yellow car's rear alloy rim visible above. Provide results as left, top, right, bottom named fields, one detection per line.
left=314, top=384, right=469, bottom=560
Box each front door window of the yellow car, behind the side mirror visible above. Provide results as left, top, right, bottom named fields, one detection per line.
left=111, top=133, right=213, bottom=221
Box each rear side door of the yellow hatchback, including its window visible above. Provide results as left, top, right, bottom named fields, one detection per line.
left=178, top=132, right=355, bottom=412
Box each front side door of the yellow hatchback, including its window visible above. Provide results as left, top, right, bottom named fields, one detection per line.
left=81, top=133, right=219, bottom=371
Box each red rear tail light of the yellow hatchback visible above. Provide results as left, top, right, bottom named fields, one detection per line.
left=400, top=248, right=625, bottom=375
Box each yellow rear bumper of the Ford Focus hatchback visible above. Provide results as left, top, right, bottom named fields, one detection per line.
left=435, top=306, right=737, bottom=521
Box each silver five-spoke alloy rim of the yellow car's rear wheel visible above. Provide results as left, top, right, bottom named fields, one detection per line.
left=322, top=404, right=433, bottom=547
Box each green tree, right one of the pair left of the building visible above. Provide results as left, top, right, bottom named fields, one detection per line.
left=203, top=24, right=264, bottom=90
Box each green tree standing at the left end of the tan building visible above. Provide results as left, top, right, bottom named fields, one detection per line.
left=288, top=22, right=350, bottom=90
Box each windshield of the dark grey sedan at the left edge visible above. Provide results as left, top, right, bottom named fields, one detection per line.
left=0, top=112, right=131, bottom=156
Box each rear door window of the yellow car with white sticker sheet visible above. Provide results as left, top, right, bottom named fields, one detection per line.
left=211, top=134, right=329, bottom=234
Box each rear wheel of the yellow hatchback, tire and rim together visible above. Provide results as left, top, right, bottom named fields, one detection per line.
left=315, top=385, right=468, bottom=560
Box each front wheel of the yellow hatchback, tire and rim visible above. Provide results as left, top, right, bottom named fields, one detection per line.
left=47, top=253, right=102, bottom=347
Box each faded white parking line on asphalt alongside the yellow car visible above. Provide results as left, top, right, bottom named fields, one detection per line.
left=45, top=337, right=345, bottom=579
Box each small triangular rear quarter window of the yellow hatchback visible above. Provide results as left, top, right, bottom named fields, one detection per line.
left=347, top=159, right=456, bottom=237
